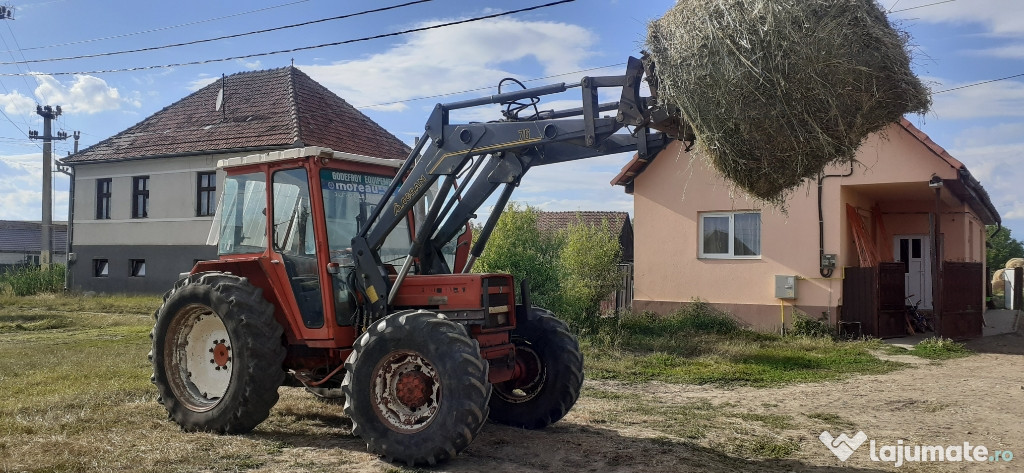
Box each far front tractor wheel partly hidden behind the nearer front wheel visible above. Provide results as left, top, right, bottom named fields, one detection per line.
left=490, top=307, right=583, bottom=429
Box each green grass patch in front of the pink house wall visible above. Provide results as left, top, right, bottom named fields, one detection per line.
left=583, top=304, right=913, bottom=387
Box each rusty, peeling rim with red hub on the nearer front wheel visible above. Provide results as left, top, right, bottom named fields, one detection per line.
left=372, top=351, right=441, bottom=433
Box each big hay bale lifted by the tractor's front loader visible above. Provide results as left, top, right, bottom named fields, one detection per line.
left=646, top=0, right=931, bottom=204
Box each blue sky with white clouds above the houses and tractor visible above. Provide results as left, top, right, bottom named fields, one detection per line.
left=0, top=0, right=1024, bottom=239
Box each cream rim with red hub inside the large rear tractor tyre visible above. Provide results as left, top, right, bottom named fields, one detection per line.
left=165, top=304, right=234, bottom=412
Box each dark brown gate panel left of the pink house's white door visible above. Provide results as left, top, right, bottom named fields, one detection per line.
left=840, top=263, right=906, bottom=338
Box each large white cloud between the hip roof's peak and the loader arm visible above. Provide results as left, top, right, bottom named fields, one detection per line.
left=300, top=18, right=594, bottom=111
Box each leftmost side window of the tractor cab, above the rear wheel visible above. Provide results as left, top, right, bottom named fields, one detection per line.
left=214, top=172, right=266, bottom=255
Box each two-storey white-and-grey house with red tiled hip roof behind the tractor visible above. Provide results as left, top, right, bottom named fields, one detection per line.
left=61, top=67, right=410, bottom=293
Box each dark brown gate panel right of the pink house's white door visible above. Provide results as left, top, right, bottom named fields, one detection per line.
left=936, top=261, right=985, bottom=340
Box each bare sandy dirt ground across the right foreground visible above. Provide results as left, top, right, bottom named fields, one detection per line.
left=247, top=333, right=1024, bottom=473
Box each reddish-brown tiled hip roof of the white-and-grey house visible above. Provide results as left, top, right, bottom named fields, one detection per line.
left=62, top=67, right=411, bottom=164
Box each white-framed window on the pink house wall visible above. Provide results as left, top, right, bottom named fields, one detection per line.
left=700, top=212, right=761, bottom=259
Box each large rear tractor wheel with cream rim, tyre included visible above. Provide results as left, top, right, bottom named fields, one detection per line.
left=150, top=272, right=285, bottom=433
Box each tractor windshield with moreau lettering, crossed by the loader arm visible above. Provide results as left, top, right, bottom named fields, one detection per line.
left=321, top=169, right=412, bottom=263
